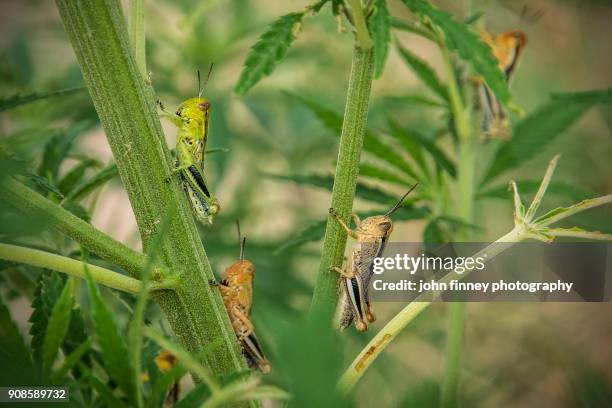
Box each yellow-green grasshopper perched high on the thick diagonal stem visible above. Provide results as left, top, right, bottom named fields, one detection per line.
left=157, top=65, right=221, bottom=225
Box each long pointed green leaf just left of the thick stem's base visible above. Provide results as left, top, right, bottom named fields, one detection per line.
left=80, top=267, right=138, bottom=404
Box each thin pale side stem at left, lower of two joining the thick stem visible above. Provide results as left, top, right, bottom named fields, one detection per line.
left=0, top=244, right=148, bottom=294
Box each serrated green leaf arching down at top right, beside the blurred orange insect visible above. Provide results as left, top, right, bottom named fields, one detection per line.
left=402, top=0, right=510, bottom=105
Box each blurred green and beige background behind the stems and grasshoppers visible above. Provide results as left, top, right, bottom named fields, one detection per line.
left=0, top=0, right=612, bottom=407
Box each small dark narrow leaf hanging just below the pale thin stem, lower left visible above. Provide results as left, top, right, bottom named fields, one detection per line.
left=29, top=271, right=64, bottom=366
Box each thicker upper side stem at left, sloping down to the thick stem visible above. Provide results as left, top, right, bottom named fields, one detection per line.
left=0, top=177, right=149, bottom=278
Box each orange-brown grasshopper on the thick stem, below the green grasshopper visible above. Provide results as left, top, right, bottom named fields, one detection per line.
left=218, top=221, right=272, bottom=374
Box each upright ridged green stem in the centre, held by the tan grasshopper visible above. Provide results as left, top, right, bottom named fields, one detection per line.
left=311, top=42, right=374, bottom=321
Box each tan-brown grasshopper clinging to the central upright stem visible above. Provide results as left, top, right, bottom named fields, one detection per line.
left=329, top=183, right=418, bottom=331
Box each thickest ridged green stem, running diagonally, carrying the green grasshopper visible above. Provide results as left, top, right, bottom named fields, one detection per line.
left=56, top=0, right=246, bottom=380
